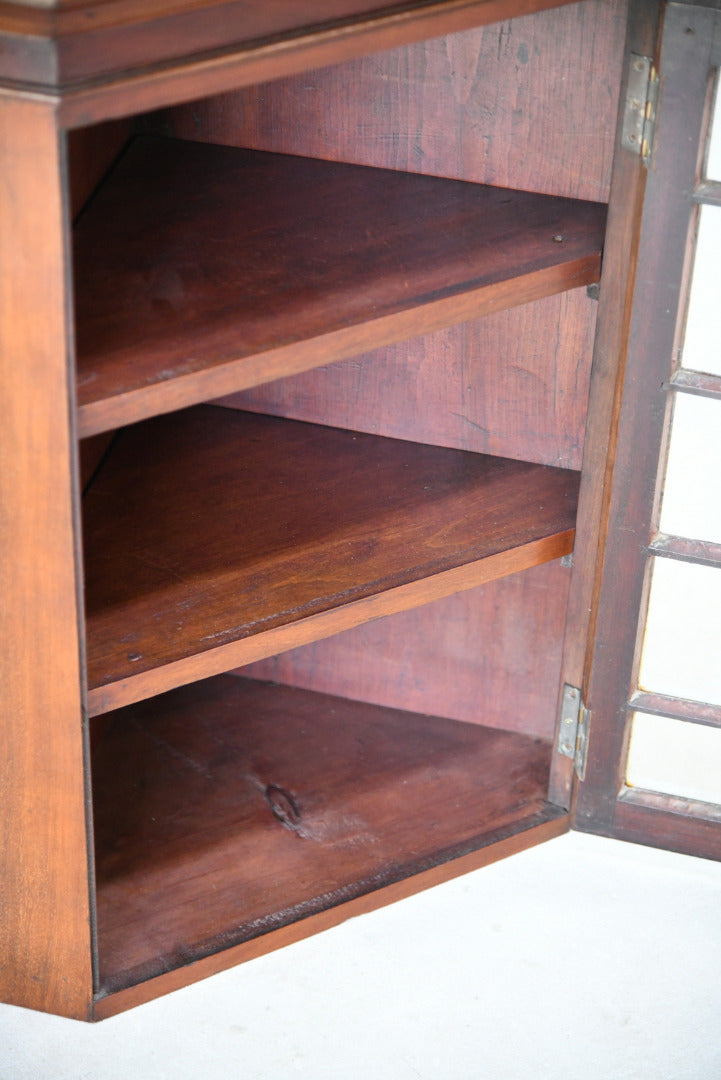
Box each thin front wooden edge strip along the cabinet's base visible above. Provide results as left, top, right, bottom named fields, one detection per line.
left=93, top=804, right=568, bottom=1020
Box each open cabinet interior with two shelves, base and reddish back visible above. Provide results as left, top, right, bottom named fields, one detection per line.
left=69, top=0, right=625, bottom=996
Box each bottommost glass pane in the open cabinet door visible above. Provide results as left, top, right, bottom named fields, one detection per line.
left=626, top=713, right=721, bottom=802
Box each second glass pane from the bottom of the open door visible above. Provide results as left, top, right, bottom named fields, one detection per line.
left=639, top=558, right=721, bottom=705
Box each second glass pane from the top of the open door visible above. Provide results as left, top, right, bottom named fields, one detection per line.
left=683, top=206, right=721, bottom=375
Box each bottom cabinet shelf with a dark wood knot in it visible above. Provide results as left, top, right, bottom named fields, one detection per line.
left=93, top=675, right=566, bottom=996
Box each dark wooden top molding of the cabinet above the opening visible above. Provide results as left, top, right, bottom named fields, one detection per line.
left=0, top=0, right=571, bottom=126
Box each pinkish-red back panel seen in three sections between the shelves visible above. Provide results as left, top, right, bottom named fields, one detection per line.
left=134, top=6, right=608, bottom=735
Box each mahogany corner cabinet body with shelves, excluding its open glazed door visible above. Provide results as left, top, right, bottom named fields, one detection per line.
left=0, top=0, right=719, bottom=1020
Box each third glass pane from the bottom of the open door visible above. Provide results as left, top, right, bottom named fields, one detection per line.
left=661, top=393, right=721, bottom=543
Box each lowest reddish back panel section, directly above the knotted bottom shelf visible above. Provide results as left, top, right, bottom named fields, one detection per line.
left=243, top=562, right=570, bottom=739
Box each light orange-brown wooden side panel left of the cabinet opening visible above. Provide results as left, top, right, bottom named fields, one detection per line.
left=0, top=98, right=92, bottom=1018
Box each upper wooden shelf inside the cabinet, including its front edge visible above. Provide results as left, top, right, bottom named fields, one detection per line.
left=74, top=138, right=606, bottom=435
